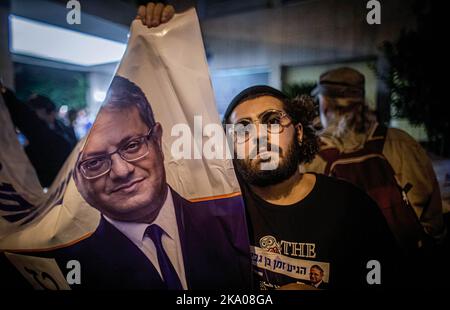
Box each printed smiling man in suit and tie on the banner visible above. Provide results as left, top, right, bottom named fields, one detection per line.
left=22, top=76, right=251, bottom=290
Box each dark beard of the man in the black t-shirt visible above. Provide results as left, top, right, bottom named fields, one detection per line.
left=235, top=140, right=302, bottom=187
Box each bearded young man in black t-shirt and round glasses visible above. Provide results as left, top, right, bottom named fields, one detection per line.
left=223, top=86, right=398, bottom=289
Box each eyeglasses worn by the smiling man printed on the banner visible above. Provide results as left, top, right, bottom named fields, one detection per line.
left=78, top=127, right=153, bottom=180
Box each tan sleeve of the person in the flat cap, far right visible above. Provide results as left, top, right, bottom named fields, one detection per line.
left=383, top=128, right=446, bottom=241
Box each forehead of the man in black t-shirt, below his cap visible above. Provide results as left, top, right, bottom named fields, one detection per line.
left=229, top=96, right=284, bottom=122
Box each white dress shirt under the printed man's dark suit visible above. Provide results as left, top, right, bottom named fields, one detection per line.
left=105, top=189, right=187, bottom=290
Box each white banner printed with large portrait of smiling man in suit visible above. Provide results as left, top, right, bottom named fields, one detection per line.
left=0, top=9, right=250, bottom=289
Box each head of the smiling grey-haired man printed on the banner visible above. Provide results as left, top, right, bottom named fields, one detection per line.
left=76, top=76, right=170, bottom=222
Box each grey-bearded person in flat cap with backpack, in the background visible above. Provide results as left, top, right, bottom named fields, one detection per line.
left=306, top=67, right=446, bottom=251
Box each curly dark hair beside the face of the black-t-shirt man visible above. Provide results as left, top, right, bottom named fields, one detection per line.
left=282, top=95, right=319, bottom=163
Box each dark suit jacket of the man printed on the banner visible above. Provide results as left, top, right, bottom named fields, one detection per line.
left=0, top=190, right=251, bottom=289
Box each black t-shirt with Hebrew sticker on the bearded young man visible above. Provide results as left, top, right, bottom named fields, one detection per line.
left=243, top=175, right=400, bottom=289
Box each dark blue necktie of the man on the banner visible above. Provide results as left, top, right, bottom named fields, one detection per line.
left=145, top=224, right=183, bottom=290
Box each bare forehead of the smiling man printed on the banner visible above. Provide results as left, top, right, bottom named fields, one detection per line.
left=83, top=107, right=148, bottom=154
